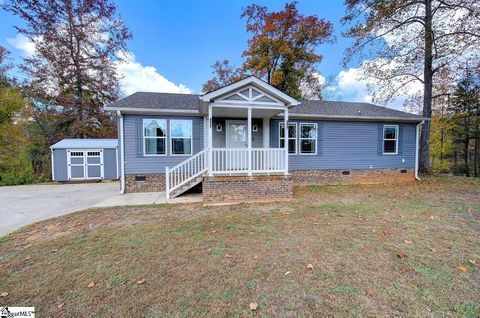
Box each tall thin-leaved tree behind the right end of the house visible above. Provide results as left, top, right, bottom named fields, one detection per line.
left=342, top=0, right=480, bottom=172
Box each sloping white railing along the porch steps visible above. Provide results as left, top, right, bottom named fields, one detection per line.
left=165, top=149, right=208, bottom=199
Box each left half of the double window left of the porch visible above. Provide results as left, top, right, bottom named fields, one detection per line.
left=143, top=119, right=167, bottom=156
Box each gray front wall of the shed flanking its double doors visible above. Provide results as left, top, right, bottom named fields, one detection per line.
left=53, top=148, right=120, bottom=181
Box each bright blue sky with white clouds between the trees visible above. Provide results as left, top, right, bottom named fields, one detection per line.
left=0, top=0, right=404, bottom=106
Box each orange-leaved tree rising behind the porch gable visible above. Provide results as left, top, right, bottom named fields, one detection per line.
left=204, top=1, right=333, bottom=98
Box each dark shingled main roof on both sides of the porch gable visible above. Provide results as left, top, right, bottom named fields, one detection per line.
left=105, top=92, right=424, bottom=122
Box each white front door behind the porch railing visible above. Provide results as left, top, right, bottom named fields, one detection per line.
left=225, top=120, right=248, bottom=170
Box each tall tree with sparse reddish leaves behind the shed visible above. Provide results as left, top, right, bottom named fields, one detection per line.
left=3, top=0, right=131, bottom=137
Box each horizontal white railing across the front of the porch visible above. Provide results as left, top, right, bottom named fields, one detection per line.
left=211, top=148, right=286, bottom=174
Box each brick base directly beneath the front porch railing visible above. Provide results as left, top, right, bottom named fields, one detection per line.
left=203, top=175, right=293, bottom=204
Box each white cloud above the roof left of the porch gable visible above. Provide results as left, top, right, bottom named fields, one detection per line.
left=115, top=53, right=192, bottom=95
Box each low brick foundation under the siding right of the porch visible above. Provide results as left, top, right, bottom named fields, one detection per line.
left=292, top=169, right=415, bottom=186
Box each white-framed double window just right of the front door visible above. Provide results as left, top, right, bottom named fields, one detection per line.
left=279, top=123, right=317, bottom=155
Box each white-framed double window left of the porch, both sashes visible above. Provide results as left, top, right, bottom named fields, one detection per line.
left=143, top=118, right=192, bottom=156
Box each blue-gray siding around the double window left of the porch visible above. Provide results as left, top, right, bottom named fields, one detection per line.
left=123, top=115, right=203, bottom=174
